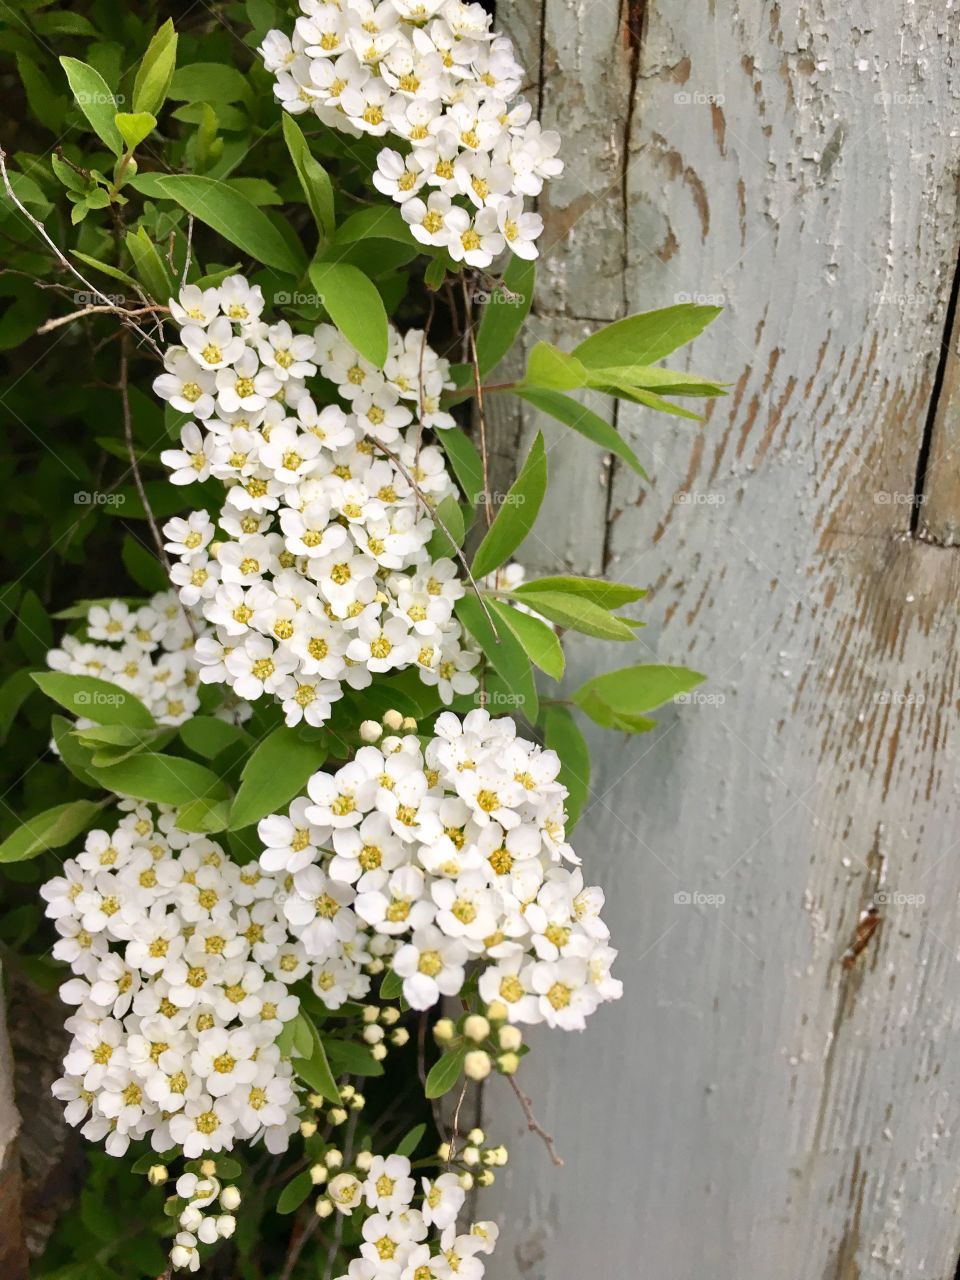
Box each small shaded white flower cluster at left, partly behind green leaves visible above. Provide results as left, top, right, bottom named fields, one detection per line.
left=46, top=591, right=200, bottom=727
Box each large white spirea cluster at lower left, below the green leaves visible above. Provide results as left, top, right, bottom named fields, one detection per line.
left=41, top=801, right=307, bottom=1158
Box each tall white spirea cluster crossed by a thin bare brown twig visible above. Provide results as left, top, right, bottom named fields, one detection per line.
left=154, top=275, right=479, bottom=726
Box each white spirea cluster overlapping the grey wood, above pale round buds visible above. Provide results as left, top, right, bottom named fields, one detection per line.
left=259, top=709, right=621, bottom=1029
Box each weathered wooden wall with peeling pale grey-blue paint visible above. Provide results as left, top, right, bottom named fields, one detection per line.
left=485, top=0, right=960, bottom=1280
